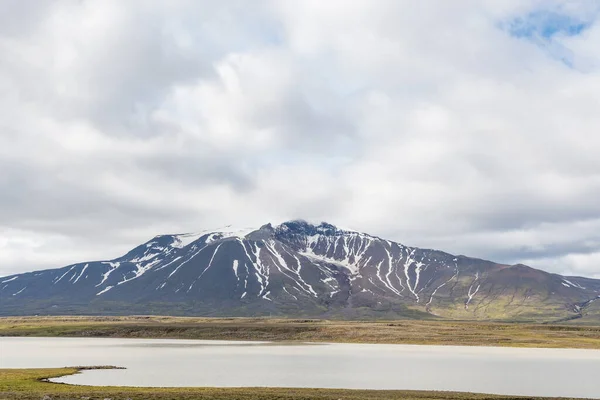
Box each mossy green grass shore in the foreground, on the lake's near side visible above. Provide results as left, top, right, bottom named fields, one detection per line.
left=0, top=368, right=580, bottom=400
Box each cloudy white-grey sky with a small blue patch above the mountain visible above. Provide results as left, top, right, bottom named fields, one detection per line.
left=0, top=0, right=600, bottom=278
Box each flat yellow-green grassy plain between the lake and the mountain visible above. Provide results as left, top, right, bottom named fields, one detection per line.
left=0, top=316, right=600, bottom=349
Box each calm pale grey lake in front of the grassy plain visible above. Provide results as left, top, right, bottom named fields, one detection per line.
left=0, top=338, right=600, bottom=398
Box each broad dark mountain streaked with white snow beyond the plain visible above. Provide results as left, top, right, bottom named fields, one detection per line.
left=0, top=221, right=600, bottom=321
